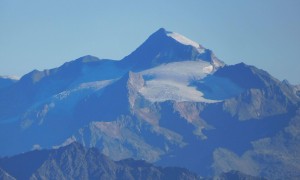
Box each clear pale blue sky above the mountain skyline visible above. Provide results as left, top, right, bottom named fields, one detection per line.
left=0, top=0, right=300, bottom=84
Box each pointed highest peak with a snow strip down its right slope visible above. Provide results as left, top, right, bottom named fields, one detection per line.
left=122, top=28, right=224, bottom=70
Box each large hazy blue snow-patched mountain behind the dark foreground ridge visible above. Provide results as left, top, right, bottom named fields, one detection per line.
left=0, top=29, right=300, bottom=179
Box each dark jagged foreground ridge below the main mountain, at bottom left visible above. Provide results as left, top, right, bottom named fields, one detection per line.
left=0, top=143, right=200, bottom=180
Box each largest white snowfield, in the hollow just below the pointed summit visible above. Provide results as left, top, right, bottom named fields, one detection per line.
left=139, top=60, right=216, bottom=103
